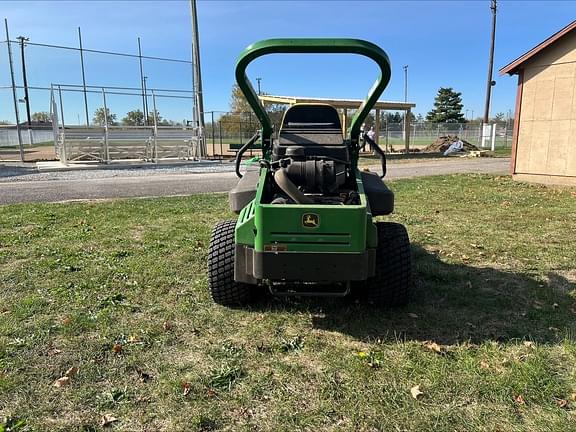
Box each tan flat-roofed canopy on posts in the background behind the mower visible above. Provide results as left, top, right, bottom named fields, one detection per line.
left=258, top=95, right=416, bottom=152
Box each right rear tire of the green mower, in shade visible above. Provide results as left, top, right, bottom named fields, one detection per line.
left=363, top=222, right=412, bottom=307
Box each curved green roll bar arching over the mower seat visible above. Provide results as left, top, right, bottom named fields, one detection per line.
left=236, top=38, right=390, bottom=151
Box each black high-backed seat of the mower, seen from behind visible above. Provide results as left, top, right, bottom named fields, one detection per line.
left=272, top=104, right=349, bottom=162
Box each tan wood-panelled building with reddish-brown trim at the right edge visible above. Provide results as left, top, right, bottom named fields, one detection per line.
left=500, top=21, right=576, bottom=185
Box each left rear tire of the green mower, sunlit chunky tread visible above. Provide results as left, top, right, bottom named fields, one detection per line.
left=208, top=220, right=253, bottom=306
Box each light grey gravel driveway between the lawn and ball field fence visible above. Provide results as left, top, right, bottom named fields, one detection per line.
left=0, top=158, right=510, bottom=204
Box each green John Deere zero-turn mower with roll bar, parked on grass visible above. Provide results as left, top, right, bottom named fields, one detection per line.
left=208, top=39, right=411, bottom=306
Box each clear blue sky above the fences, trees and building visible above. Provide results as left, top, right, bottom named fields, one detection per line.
left=0, top=0, right=576, bottom=122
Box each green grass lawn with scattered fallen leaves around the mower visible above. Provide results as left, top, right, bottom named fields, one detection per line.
left=0, top=175, right=576, bottom=431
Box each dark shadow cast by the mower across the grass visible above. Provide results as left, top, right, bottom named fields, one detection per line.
left=263, top=245, right=576, bottom=344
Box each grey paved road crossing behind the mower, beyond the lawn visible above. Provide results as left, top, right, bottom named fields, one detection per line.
left=0, top=158, right=510, bottom=204
